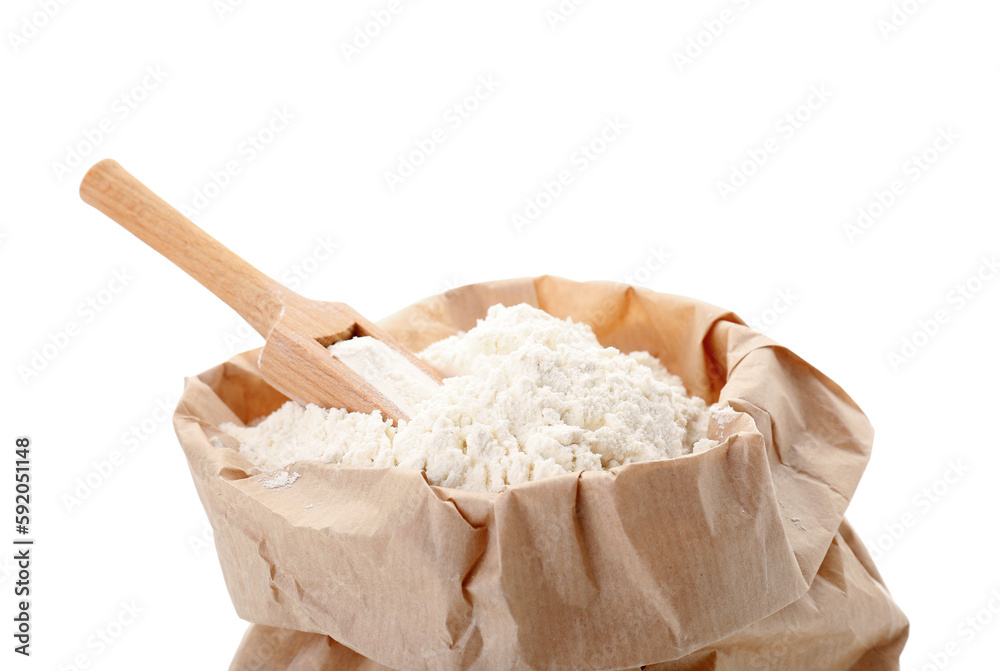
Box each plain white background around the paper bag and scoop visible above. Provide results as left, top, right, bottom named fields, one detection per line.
left=0, top=0, right=1000, bottom=670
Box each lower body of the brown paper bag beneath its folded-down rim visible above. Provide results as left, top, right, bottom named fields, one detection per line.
left=230, top=522, right=907, bottom=671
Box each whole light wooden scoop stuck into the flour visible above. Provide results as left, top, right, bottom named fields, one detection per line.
left=80, top=159, right=441, bottom=422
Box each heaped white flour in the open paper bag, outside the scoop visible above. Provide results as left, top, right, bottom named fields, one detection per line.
left=221, top=305, right=715, bottom=492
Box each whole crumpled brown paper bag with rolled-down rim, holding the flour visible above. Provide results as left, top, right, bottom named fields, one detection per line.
left=175, top=277, right=908, bottom=670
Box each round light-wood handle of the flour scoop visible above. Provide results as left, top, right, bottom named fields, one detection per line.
left=80, top=159, right=292, bottom=338
